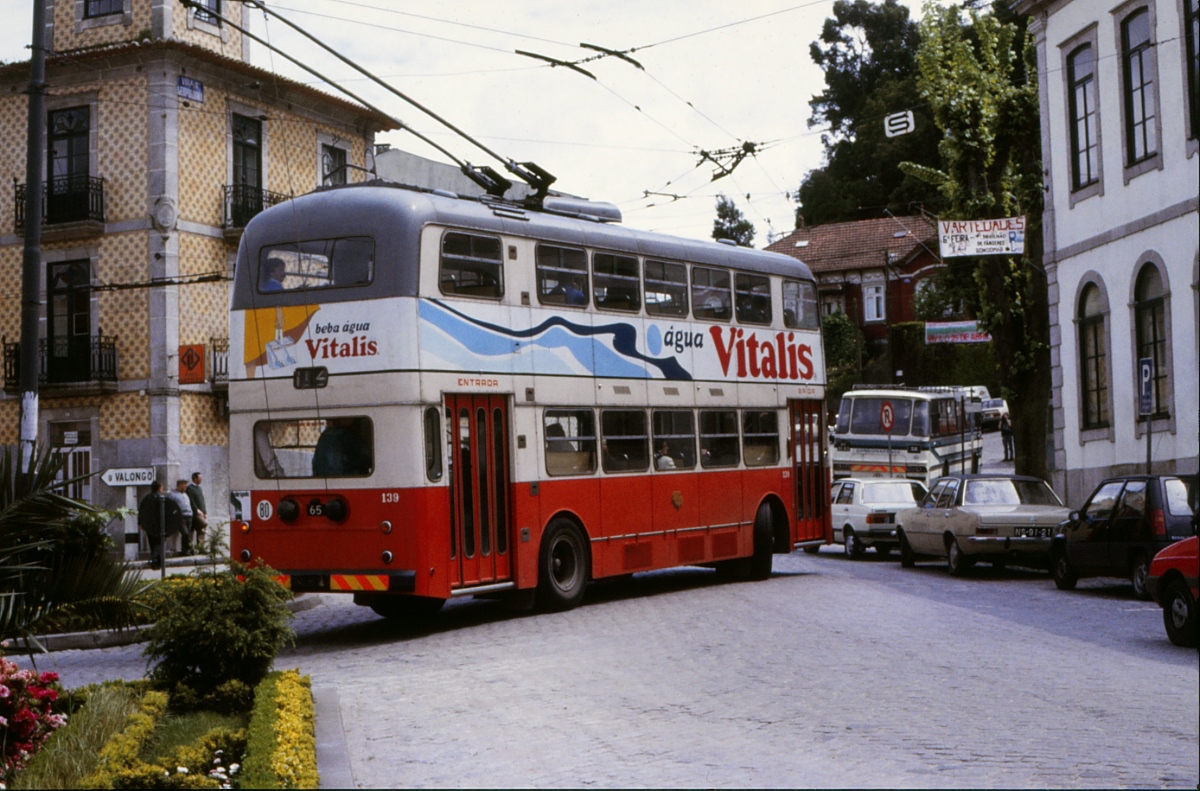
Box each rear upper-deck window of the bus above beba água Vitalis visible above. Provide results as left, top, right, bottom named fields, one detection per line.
left=258, top=236, right=374, bottom=293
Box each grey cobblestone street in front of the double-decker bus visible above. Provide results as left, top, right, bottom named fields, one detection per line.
left=30, top=547, right=1200, bottom=787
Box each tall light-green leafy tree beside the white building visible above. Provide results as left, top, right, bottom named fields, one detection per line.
left=904, top=2, right=1051, bottom=478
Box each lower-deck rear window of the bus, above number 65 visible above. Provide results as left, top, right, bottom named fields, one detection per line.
left=254, top=418, right=374, bottom=479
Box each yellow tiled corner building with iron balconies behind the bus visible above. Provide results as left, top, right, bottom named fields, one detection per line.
left=0, top=0, right=392, bottom=544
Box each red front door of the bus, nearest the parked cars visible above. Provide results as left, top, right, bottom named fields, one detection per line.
left=787, top=400, right=832, bottom=541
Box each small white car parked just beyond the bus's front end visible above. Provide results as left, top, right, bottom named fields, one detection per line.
left=829, top=478, right=926, bottom=561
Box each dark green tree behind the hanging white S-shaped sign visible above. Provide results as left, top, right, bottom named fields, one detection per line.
left=796, top=0, right=941, bottom=226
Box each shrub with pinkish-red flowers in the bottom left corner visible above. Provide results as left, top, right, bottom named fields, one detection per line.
left=0, top=657, right=67, bottom=786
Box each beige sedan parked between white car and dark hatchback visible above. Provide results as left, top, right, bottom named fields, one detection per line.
left=896, top=474, right=1070, bottom=576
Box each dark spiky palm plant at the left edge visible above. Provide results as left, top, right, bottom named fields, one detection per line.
left=0, top=448, right=144, bottom=647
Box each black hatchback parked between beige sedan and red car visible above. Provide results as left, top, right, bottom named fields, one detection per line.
left=1050, top=475, right=1192, bottom=599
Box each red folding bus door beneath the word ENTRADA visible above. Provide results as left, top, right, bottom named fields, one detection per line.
left=446, top=394, right=512, bottom=587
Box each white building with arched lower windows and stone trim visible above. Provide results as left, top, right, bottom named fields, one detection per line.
left=1014, top=0, right=1200, bottom=505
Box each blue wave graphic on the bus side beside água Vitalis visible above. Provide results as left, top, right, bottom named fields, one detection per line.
left=420, top=300, right=692, bottom=380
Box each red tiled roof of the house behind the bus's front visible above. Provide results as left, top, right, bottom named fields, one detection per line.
left=767, top=215, right=937, bottom=272
